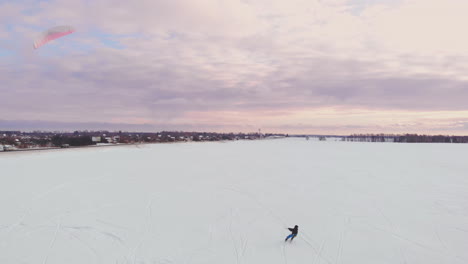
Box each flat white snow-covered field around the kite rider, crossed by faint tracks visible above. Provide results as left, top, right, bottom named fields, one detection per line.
left=0, top=138, right=468, bottom=264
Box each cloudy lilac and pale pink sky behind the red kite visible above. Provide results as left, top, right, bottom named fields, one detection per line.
left=0, top=0, right=468, bottom=135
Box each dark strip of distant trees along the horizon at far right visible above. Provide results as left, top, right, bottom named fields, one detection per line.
left=343, top=134, right=468, bottom=143
